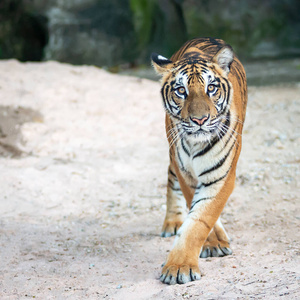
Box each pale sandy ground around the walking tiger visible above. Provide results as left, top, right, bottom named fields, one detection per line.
left=0, top=60, right=300, bottom=300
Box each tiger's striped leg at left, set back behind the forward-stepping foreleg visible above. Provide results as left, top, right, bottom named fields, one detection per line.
left=161, top=166, right=186, bottom=237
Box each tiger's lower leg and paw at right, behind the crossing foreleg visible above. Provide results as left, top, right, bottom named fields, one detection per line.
left=200, top=219, right=232, bottom=258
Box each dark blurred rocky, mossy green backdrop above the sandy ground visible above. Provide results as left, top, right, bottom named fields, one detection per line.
left=0, top=0, right=300, bottom=68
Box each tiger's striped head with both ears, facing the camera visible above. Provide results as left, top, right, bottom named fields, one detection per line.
left=151, top=46, right=234, bottom=142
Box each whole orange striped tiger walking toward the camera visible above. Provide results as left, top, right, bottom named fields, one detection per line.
left=151, top=38, right=247, bottom=284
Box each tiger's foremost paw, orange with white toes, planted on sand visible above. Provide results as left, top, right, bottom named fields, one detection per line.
left=160, top=264, right=201, bottom=285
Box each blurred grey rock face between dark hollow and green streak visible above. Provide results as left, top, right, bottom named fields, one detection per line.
left=45, top=0, right=136, bottom=66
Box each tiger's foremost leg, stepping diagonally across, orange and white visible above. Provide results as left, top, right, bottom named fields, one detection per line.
left=160, top=175, right=234, bottom=284
